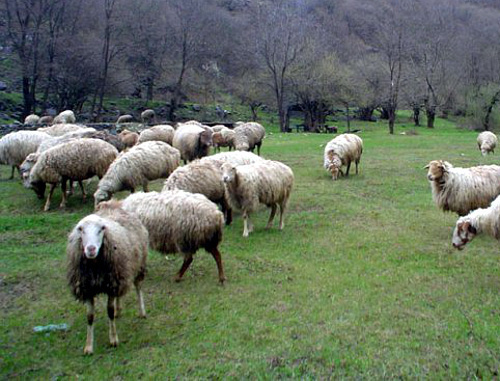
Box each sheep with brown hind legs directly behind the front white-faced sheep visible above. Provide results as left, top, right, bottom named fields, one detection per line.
left=119, top=190, right=226, bottom=284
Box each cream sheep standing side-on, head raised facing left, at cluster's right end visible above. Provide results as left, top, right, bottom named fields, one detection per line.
left=222, top=160, right=294, bottom=237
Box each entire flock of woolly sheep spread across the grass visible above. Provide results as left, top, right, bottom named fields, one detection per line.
left=0, top=110, right=500, bottom=354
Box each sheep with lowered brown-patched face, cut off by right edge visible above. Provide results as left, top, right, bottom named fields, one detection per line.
left=451, top=197, right=500, bottom=250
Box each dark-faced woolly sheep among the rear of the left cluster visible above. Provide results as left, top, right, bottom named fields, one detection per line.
left=172, top=123, right=212, bottom=163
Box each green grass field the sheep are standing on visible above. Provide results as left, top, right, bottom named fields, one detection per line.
left=0, top=120, right=500, bottom=380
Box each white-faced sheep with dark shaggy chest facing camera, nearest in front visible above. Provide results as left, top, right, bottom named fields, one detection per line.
left=66, top=205, right=149, bottom=355
